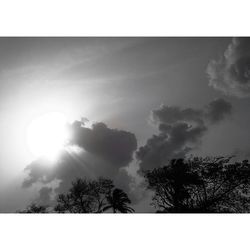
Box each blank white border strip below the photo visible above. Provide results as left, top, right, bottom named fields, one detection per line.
left=0, top=214, right=250, bottom=250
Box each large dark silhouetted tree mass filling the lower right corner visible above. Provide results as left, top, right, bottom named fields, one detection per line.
left=145, top=157, right=250, bottom=213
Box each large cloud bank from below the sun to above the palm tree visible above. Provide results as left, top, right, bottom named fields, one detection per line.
left=23, top=121, right=137, bottom=205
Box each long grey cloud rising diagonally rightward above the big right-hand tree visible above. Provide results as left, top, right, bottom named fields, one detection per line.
left=136, top=99, right=231, bottom=170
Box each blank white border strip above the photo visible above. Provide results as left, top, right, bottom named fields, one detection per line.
left=0, top=0, right=249, bottom=36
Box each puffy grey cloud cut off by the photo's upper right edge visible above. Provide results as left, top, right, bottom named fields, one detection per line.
left=207, top=38, right=250, bottom=98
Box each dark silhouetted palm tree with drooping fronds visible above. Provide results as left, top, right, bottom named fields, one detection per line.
left=103, top=188, right=134, bottom=213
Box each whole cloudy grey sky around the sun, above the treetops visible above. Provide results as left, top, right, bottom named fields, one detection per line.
left=0, top=37, right=250, bottom=212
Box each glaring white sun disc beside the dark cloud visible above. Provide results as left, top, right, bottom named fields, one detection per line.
left=26, top=112, right=68, bottom=161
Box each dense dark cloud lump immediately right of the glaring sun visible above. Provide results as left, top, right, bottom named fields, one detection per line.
left=71, top=122, right=137, bottom=167
